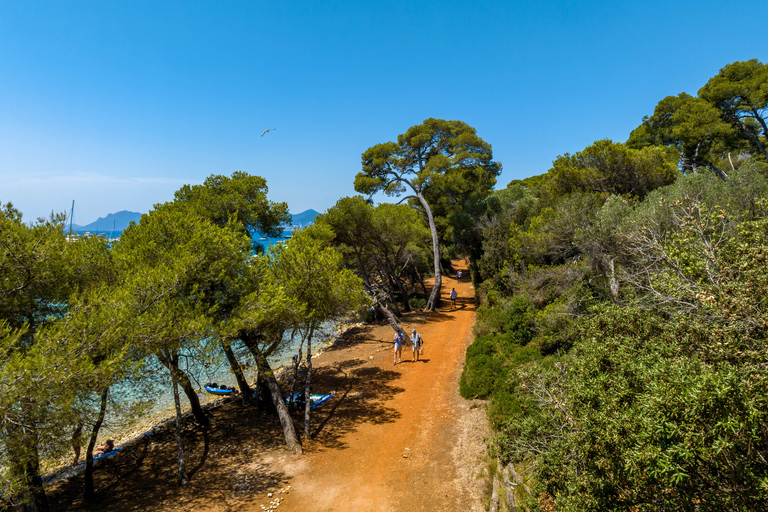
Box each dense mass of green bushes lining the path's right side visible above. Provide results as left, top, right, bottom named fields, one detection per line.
left=460, top=137, right=768, bottom=511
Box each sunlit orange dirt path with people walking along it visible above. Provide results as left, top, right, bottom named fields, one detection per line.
left=281, top=264, right=482, bottom=511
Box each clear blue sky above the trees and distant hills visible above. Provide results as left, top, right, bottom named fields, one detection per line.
left=0, top=0, right=768, bottom=224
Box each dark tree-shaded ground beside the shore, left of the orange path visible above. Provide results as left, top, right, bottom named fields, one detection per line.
left=47, top=402, right=287, bottom=511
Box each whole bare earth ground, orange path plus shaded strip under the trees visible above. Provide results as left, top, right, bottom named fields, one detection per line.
left=51, top=262, right=488, bottom=512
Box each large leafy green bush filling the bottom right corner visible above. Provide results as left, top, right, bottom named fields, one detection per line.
left=529, top=308, right=768, bottom=510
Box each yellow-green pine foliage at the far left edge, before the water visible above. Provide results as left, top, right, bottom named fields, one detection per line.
left=0, top=204, right=128, bottom=507
